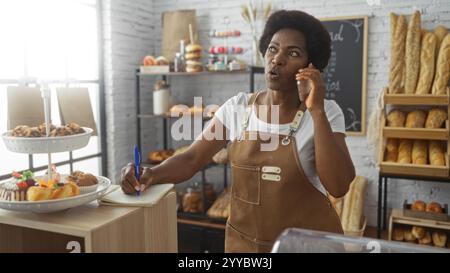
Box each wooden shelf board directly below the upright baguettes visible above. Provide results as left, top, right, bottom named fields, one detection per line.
left=384, top=88, right=450, bottom=106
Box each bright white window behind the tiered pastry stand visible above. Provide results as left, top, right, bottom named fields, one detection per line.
left=0, top=0, right=105, bottom=180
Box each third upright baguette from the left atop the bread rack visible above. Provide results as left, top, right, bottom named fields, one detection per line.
left=416, top=32, right=437, bottom=94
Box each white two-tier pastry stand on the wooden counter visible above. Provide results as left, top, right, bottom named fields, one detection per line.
left=0, top=84, right=111, bottom=213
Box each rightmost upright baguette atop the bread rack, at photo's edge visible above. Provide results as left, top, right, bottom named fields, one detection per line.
left=431, top=33, right=450, bottom=95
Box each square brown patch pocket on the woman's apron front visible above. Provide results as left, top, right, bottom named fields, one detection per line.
left=231, top=163, right=261, bottom=205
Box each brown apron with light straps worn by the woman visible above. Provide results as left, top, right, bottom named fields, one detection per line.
left=225, top=94, right=343, bottom=252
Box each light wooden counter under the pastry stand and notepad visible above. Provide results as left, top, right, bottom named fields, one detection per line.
left=0, top=191, right=177, bottom=253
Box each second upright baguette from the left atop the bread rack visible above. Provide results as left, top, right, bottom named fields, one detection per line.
left=405, top=11, right=420, bottom=94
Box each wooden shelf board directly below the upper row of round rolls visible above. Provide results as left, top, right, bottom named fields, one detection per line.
left=383, top=120, right=449, bottom=141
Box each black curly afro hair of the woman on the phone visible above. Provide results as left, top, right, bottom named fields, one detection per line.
left=259, top=10, right=331, bottom=71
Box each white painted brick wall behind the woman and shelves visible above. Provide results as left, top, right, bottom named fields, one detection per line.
left=103, top=0, right=450, bottom=225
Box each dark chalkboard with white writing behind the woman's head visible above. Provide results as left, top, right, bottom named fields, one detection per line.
left=321, top=16, right=368, bottom=135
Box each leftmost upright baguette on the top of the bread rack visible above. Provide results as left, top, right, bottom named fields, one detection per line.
left=389, top=13, right=407, bottom=94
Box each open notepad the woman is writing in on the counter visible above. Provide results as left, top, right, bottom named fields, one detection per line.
left=100, top=184, right=174, bottom=207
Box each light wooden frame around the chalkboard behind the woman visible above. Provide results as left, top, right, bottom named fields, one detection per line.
left=319, top=15, right=369, bottom=136
